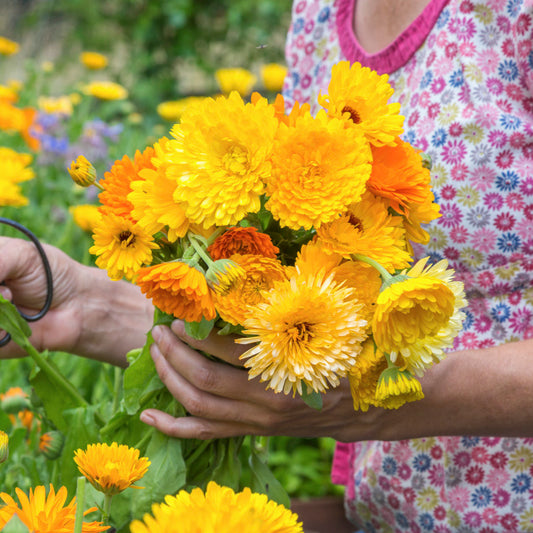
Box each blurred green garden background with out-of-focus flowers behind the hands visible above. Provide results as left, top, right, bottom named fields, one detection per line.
left=0, top=0, right=340, bottom=528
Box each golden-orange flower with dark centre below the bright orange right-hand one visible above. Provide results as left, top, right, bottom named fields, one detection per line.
left=317, top=192, right=411, bottom=272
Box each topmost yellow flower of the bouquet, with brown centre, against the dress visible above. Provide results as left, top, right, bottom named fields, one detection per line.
left=318, top=61, right=404, bottom=146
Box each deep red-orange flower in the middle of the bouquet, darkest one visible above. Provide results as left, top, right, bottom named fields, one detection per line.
left=207, top=226, right=279, bottom=260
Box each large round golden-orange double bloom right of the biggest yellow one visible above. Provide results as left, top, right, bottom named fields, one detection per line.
left=266, top=111, right=372, bottom=230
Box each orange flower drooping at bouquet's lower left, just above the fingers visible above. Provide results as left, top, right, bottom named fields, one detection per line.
left=135, top=261, right=216, bottom=322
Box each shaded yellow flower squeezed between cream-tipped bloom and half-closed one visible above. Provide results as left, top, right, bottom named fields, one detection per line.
left=348, top=338, right=387, bottom=411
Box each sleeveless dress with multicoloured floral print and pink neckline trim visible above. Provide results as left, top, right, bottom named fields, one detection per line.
left=284, top=0, right=533, bottom=533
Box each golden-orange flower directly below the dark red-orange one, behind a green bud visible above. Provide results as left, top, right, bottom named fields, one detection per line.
left=213, top=254, right=287, bottom=326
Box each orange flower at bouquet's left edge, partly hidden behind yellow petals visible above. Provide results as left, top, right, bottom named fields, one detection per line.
left=98, top=146, right=155, bottom=217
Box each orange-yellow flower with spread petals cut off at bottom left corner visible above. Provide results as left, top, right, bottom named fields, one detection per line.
left=0, top=485, right=109, bottom=533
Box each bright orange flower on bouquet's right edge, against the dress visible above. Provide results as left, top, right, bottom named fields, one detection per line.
left=367, top=139, right=431, bottom=214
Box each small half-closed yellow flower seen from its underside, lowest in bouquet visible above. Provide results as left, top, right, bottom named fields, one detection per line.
left=376, top=367, right=424, bottom=409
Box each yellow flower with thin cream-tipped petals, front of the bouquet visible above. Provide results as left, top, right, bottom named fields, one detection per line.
left=236, top=272, right=367, bottom=394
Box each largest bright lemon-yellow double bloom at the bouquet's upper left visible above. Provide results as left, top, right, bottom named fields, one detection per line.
left=163, top=92, right=278, bottom=229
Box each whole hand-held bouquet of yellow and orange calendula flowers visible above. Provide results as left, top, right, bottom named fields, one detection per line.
left=77, top=62, right=466, bottom=410
